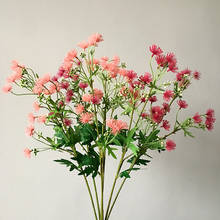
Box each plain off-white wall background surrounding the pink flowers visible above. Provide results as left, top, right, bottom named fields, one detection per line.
left=0, top=0, right=220, bottom=220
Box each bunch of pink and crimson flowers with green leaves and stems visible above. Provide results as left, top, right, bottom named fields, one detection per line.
left=3, top=34, right=215, bottom=220
